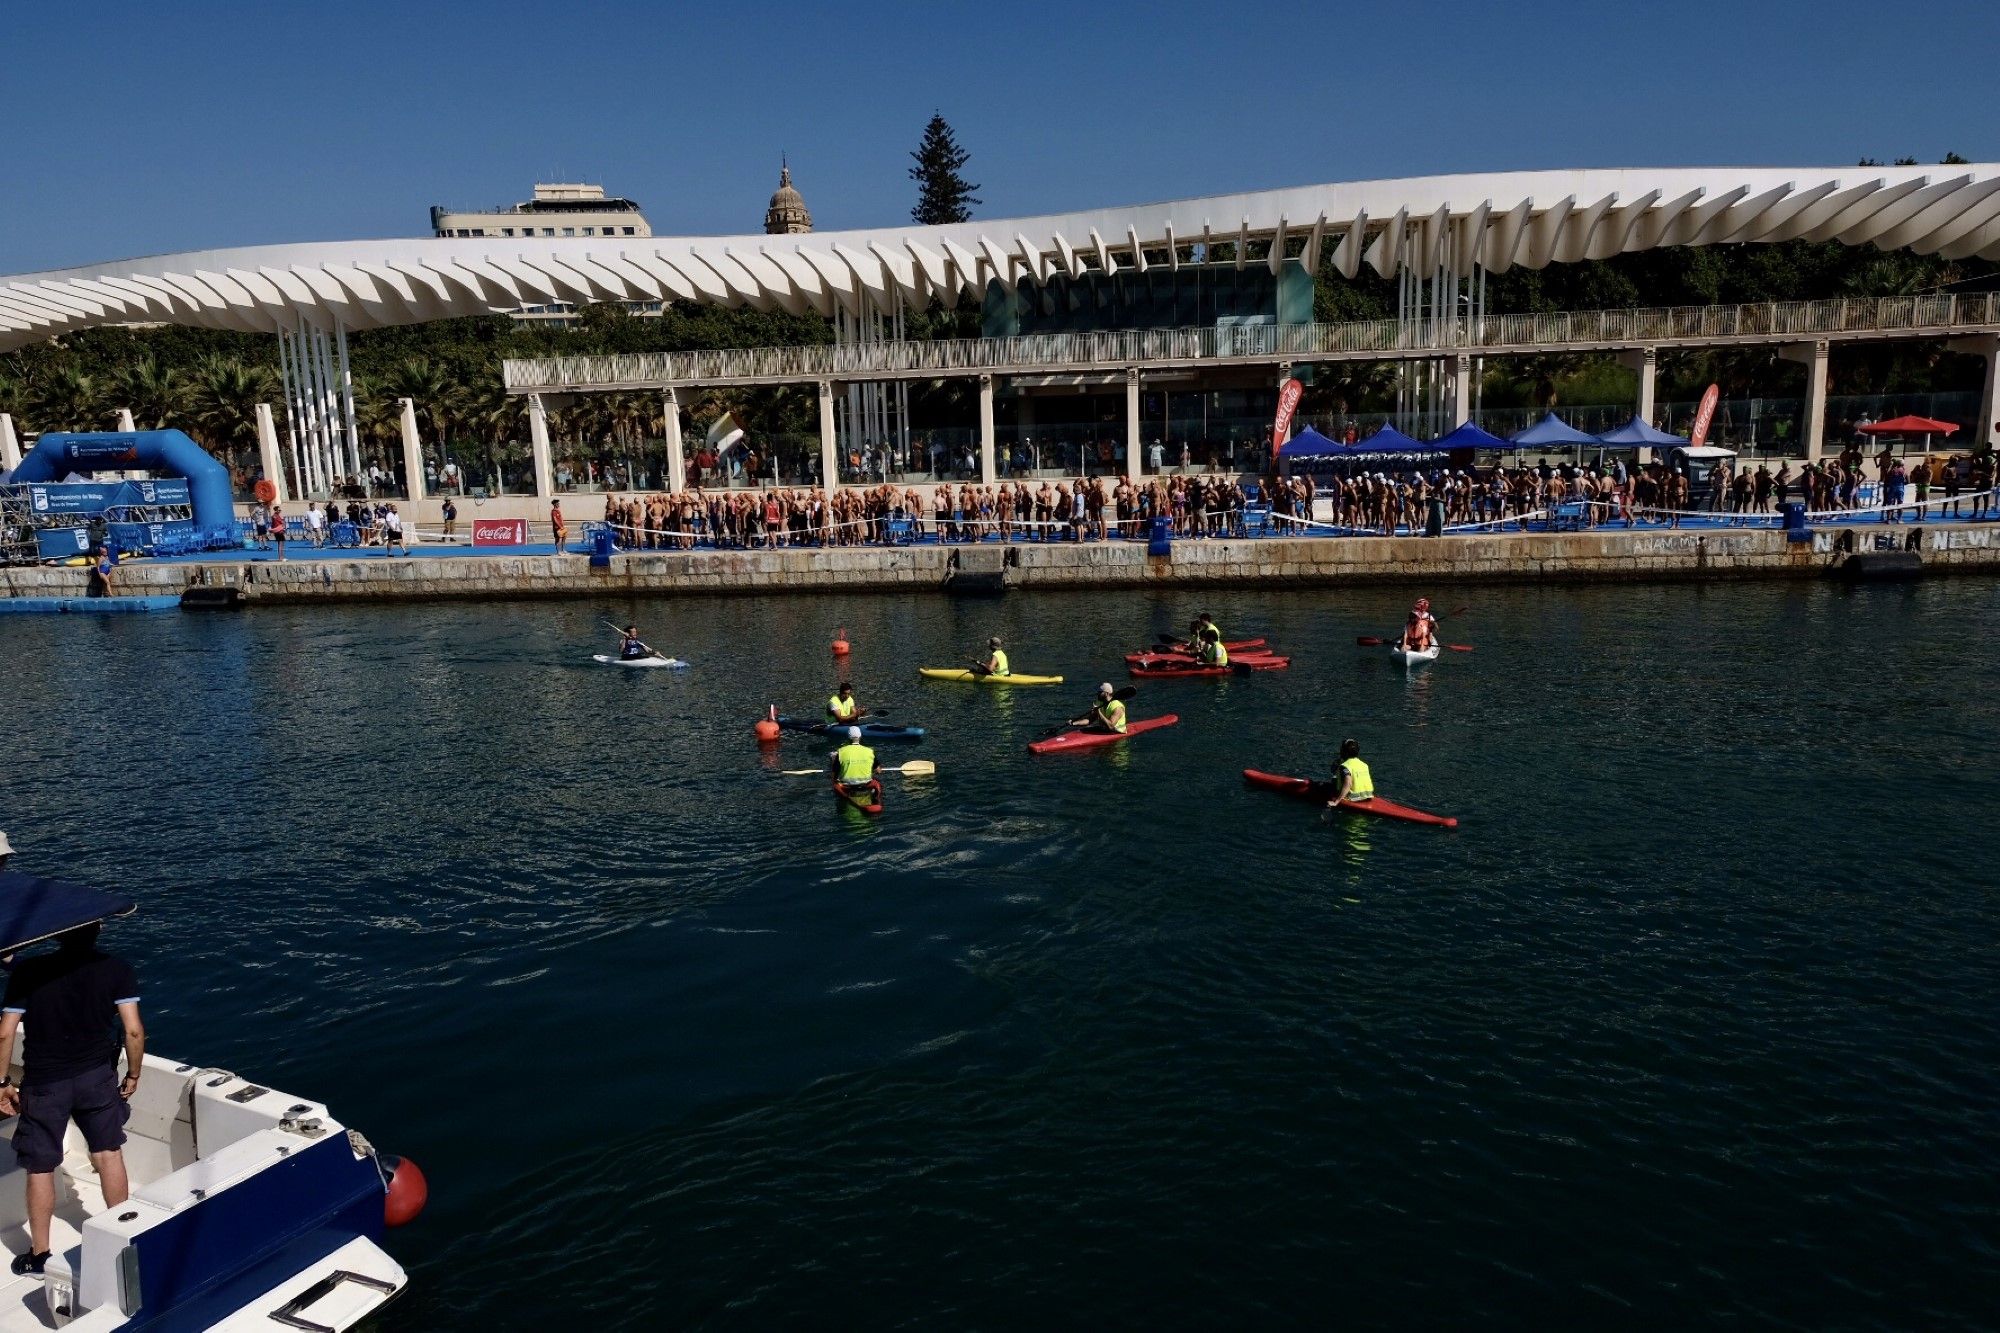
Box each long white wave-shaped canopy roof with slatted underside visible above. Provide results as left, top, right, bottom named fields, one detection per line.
left=0, top=164, right=2000, bottom=350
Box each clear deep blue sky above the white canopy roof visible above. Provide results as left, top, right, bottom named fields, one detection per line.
left=0, top=0, right=2000, bottom=272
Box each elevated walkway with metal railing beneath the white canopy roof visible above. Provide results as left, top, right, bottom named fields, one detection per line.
left=506, top=292, right=2000, bottom=392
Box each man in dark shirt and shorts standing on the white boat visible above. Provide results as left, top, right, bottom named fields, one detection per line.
left=0, top=923, right=146, bottom=1275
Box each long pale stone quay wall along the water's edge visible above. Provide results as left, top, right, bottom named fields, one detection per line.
left=0, top=524, right=2000, bottom=604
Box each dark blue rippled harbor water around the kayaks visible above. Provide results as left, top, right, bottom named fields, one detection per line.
left=0, top=580, right=2000, bottom=1329
